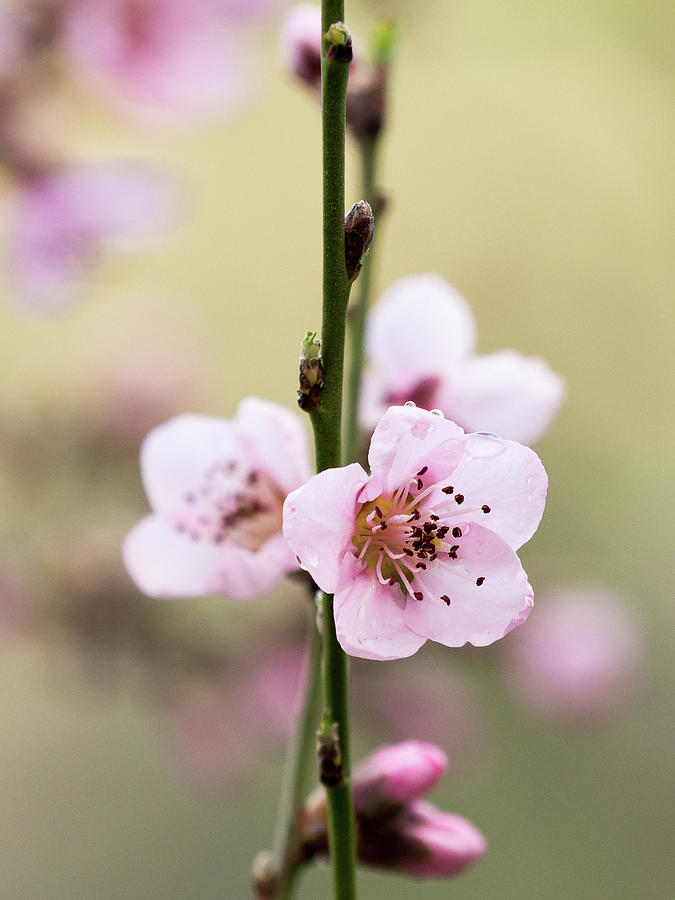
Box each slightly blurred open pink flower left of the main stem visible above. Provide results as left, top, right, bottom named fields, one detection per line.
left=124, top=397, right=310, bottom=600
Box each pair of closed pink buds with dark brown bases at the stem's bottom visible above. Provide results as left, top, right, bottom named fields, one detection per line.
left=303, top=740, right=486, bottom=878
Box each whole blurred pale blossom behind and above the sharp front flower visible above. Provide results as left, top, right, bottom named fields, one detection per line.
left=362, top=275, right=565, bottom=444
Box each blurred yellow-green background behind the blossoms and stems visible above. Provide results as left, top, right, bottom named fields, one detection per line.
left=0, top=0, right=675, bottom=900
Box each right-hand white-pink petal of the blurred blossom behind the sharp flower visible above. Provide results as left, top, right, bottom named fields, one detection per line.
left=446, top=350, right=565, bottom=444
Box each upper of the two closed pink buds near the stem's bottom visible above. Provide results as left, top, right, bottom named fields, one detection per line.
left=352, top=740, right=448, bottom=812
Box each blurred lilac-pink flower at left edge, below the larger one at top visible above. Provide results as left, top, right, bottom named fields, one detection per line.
left=10, top=163, right=175, bottom=311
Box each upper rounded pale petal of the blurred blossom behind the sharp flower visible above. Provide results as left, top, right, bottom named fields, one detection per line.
left=366, top=275, right=476, bottom=393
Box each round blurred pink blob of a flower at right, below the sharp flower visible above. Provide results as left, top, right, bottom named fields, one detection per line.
left=505, top=586, right=643, bottom=721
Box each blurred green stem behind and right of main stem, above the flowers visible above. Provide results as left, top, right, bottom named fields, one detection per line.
left=344, top=135, right=378, bottom=462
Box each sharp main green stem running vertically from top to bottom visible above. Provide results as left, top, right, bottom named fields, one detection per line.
left=310, top=0, right=356, bottom=900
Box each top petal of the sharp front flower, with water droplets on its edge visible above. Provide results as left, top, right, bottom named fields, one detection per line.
left=360, top=406, right=466, bottom=501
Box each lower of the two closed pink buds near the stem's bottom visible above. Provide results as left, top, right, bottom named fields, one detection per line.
left=397, top=800, right=487, bottom=878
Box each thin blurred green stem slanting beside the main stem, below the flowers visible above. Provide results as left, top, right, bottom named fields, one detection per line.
left=274, top=621, right=321, bottom=900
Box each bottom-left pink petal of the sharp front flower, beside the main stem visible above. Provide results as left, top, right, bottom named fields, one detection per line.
left=334, top=557, right=426, bottom=659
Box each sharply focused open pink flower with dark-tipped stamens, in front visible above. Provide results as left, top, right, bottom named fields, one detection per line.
left=284, top=406, right=547, bottom=659
